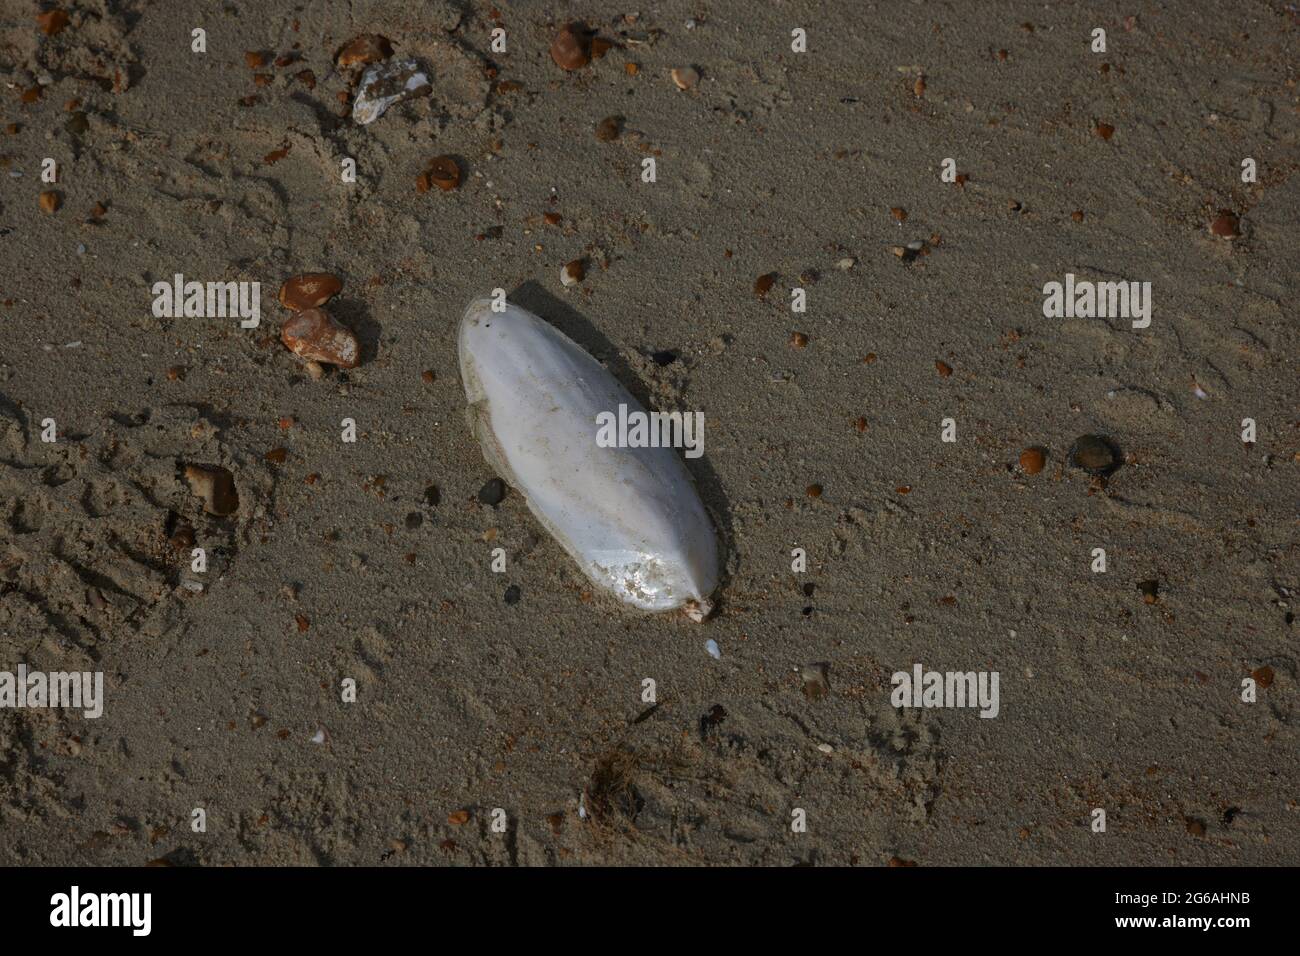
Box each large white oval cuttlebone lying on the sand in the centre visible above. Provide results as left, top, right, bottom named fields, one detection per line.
left=459, top=298, right=718, bottom=620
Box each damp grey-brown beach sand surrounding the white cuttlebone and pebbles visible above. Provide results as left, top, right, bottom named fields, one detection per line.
left=0, top=0, right=1300, bottom=866
